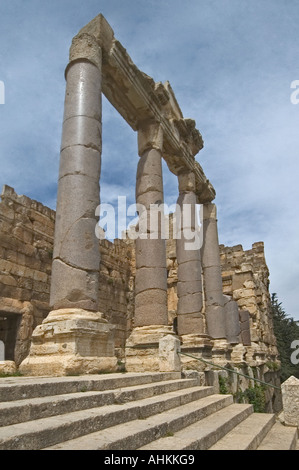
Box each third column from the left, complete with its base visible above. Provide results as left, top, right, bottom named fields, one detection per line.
left=176, top=170, right=212, bottom=369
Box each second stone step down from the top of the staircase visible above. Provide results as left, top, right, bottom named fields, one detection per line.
left=0, top=378, right=203, bottom=426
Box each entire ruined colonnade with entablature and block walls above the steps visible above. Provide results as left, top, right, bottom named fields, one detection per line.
left=0, top=15, right=279, bottom=410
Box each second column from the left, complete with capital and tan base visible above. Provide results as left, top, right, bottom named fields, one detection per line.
left=126, top=122, right=177, bottom=371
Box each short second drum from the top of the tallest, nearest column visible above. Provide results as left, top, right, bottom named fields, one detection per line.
left=60, top=116, right=102, bottom=152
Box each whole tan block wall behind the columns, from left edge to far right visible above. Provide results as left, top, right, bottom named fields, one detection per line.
left=0, top=186, right=279, bottom=392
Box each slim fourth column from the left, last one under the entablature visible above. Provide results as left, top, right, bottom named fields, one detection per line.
left=202, top=203, right=232, bottom=357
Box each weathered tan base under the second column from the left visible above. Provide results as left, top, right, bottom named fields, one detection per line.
left=126, top=325, right=180, bottom=372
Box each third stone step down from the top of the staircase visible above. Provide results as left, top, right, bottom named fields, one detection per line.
left=0, top=386, right=217, bottom=450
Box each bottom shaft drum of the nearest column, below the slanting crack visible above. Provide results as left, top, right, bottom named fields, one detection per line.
left=50, top=259, right=99, bottom=311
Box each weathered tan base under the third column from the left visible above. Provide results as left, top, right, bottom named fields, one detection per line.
left=180, top=334, right=213, bottom=371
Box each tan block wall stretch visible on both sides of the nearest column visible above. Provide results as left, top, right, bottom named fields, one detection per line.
left=0, top=186, right=135, bottom=364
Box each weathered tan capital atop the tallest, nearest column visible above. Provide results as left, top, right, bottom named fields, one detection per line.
left=65, top=33, right=102, bottom=76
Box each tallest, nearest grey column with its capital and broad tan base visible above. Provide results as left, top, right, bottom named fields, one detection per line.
left=21, top=34, right=116, bottom=375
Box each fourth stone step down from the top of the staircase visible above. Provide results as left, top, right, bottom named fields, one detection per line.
left=45, top=394, right=234, bottom=450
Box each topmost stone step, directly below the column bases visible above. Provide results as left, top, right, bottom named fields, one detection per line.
left=0, top=372, right=181, bottom=402
